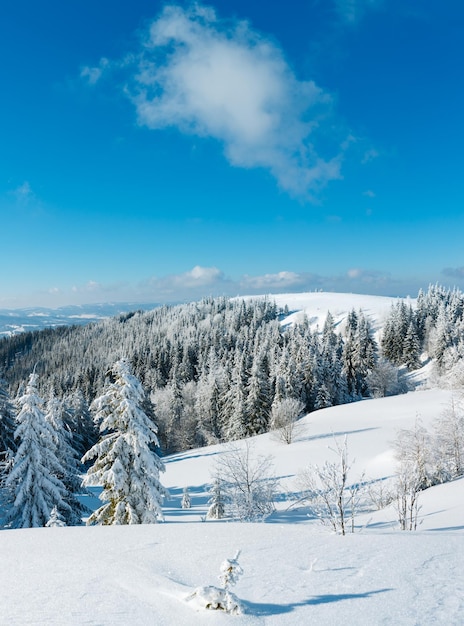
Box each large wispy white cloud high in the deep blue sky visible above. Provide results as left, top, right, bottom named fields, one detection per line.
left=129, top=5, right=341, bottom=195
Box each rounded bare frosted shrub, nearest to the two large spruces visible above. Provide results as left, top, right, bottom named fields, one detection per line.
left=216, top=440, right=277, bottom=522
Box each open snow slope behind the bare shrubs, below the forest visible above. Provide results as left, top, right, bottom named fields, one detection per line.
left=163, top=389, right=456, bottom=528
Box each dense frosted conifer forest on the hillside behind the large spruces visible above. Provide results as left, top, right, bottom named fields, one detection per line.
left=0, top=287, right=464, bottom=452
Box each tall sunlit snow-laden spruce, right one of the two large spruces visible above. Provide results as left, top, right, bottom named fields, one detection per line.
left=82, top=359, right=168, bottom=525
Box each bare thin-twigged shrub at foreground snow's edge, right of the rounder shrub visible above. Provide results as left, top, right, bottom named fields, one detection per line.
left=298, top=437, right=363, bottom=535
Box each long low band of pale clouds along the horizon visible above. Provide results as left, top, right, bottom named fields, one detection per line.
left=0, top=265, right=428, bottom=308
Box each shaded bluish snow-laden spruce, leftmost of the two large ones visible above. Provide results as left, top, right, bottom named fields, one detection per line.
left=5, top=373, right=70, bottom=528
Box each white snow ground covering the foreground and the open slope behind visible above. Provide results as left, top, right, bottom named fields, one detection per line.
left=0, top=294, right=464, bottom=626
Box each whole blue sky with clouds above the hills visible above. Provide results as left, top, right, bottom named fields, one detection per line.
left=0, top=0, right=464, bottom=308
